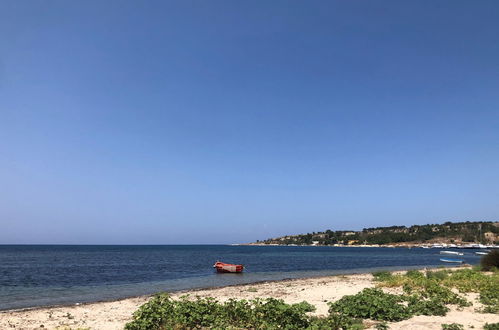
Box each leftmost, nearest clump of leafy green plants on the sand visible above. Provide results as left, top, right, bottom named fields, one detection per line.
left=125, top=294, right=362, bottom=330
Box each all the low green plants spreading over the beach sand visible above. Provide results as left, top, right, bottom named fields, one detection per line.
left=125, top=269, right=499, bottom=330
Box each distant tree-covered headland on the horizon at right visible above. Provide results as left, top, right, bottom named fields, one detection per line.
left=258, top=221, right=499, bottom=245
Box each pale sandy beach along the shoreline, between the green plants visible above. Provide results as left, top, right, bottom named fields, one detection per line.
left=0, top=274, right=499, bottom=330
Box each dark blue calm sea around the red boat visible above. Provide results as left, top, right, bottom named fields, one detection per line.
left=0, top=245, right=479, bottom=310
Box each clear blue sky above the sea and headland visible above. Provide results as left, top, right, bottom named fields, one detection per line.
left=0, top=0, right=499, bottom=244
